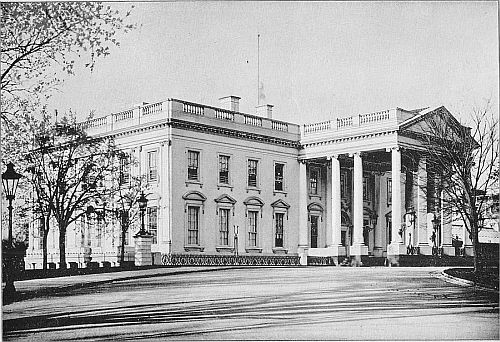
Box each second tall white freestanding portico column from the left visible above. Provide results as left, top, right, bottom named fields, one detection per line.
left=352, top=152, right=364, bottom=245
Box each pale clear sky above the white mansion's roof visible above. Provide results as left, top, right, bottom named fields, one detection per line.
left=46, top=1, right=499, bottom=124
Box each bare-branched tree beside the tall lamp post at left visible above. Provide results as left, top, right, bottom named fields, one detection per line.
left=27, top=118, right=118, bottom=268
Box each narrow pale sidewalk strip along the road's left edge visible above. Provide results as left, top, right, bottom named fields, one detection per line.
left=1, top=267, right=232, bottom=301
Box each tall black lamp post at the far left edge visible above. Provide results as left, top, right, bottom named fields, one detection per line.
left=2, top=162, right=22, bottom=300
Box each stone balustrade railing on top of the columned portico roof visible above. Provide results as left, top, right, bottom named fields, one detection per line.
left=303, top=109, right=397, bottom=135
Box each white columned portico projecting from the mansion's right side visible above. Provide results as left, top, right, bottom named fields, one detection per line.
left=299, top=108, right=451, bottom=265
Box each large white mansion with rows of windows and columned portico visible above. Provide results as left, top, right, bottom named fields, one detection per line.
left=25, top=96, right=471, bottom=268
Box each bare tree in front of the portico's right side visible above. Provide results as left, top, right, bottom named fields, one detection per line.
left=412, top=102, right=499, bottom=273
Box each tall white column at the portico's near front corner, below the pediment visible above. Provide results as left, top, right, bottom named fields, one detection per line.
left=391, top=148, right=403, bottom=244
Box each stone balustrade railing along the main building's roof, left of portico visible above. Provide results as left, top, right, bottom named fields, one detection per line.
left=77, top=99, right=299, bottom=134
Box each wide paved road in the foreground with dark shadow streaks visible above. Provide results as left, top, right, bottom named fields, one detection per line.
left=3, top=267, right=499, bottom=341
